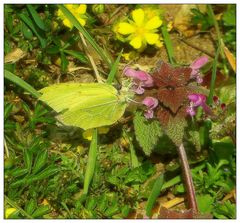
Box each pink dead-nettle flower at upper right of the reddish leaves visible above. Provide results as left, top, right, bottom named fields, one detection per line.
left=190, top=56, right=208, bottom=84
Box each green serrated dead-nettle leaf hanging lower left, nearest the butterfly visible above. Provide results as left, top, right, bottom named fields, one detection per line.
left=133, top=112, right=163, bottom=156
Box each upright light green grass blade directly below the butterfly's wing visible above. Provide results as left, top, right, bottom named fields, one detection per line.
left=83, top=129, right=98, bottom=194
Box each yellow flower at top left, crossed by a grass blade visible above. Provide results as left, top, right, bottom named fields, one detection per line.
left=57, top=4, right=87, bottom=29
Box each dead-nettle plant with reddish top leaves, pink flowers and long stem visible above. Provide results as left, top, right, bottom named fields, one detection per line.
left=124, top=57, right=212, bottom=214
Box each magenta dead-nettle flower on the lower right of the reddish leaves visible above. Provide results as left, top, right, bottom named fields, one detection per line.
left=186, top=94, right=212, bottom=117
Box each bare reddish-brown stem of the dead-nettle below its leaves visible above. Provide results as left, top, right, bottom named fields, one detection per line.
left=177, top=144, right=198, bottom=215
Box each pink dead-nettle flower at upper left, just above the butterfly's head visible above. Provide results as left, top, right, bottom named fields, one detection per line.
left=123, top=67, right=153, bottom=94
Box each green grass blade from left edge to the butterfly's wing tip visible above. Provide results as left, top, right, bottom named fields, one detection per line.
left=4, top=70, right=41, bottom=98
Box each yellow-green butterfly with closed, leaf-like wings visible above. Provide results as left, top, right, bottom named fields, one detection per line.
left=39, top=83, right=131, bottom=130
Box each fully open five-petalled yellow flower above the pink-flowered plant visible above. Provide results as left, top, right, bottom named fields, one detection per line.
left=116, top=9, right=162, bottom=49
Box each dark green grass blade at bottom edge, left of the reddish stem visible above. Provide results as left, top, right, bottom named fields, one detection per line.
left=146, top=174, right=164, bottom=216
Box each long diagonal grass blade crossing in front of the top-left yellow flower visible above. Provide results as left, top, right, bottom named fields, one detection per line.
left=58, top=5, right=112, bottom=68
